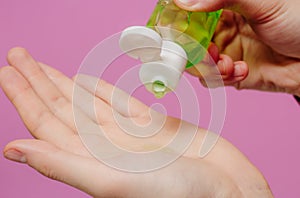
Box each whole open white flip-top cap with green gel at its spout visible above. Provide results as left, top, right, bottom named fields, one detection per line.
left=119, top=26, right=187, bottom=97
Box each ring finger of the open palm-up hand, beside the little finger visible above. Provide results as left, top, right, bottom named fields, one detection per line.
left=39, top=63, right=113, bottom=124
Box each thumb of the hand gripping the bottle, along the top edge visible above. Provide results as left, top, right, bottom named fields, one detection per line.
left=174, top=0, right=281, bottom=21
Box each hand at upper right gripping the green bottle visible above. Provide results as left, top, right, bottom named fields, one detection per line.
left=174, top=0, right=300, bottom=96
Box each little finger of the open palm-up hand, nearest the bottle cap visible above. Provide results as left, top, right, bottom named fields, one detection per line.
left=75, top=74, right=149, bottom=117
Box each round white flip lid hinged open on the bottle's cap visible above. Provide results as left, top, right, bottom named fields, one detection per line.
left=119, top=26, right=162, bottom=63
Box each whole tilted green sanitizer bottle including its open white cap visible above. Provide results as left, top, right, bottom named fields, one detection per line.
left=119, top=0, right=222, bottom=98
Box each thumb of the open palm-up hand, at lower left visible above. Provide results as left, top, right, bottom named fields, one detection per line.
left=4, top=140, right=124, bottom=197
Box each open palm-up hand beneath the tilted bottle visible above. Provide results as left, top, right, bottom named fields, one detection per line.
left=0, top=48, right=272, bottom=198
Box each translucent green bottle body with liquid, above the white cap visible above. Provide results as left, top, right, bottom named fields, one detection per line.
left=147, top=0, right=222, bottom=68
